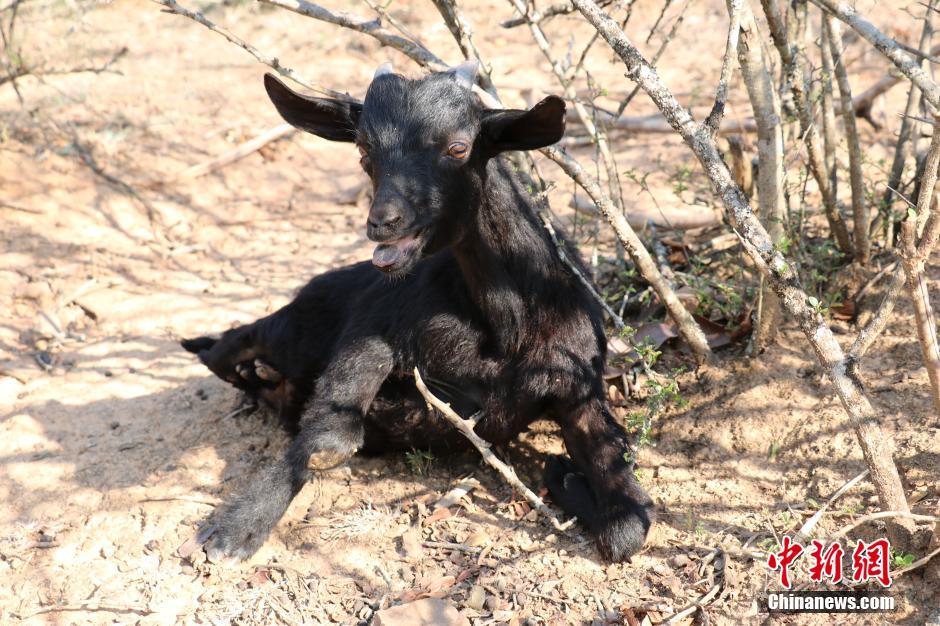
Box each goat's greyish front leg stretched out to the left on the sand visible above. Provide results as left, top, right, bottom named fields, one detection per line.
left=200, top=337, right=393, bottom=560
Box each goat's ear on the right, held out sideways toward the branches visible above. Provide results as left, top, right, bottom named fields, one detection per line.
left=481, top=96, right=565, bottom=153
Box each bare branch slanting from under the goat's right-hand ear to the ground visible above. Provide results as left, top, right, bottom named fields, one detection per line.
left=541, top=148, right=711, bottom=361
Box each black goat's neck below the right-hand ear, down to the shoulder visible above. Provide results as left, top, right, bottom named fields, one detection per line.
left=454, top=159, right=574, bottom=352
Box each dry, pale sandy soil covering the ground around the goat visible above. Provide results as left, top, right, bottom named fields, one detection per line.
left=0, top=0, right=940, bottom=624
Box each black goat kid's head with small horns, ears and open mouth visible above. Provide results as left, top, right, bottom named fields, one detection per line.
left=265, top=63, right=565, bottom=275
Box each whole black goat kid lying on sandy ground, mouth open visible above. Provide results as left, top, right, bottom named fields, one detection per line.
left=183, top=65, right=652, bottom=561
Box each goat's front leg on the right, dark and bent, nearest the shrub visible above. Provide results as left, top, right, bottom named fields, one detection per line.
left=545, top=400, right=653, bottom=561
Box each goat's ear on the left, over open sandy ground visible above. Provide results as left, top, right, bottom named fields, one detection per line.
left=264, top=74, right=362, bottom=141
